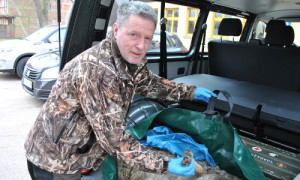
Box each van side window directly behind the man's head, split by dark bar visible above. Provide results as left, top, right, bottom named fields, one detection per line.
left=109, top=0, right=195, bottom=53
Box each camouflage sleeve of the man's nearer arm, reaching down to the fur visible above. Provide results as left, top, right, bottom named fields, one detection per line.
left=76, top=48, right=167, bottom=173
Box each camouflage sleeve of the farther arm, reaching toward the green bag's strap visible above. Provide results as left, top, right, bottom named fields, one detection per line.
left=136, top=67, right=196, bottom=102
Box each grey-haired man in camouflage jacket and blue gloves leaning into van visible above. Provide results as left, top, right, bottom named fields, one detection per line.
left=25, top=1, right=216, bottom=179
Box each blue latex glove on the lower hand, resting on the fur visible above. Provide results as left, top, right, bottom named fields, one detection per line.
left=168, top=157, right=196, bottom=176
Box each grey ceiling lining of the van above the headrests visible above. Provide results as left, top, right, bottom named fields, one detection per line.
left=207, top=0, right=300, bottom=19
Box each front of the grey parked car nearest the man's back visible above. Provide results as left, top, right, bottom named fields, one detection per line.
left=22, top=51, right=60, bottom=100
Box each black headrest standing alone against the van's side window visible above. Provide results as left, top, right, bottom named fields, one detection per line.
left=218, top=18, right=242, bottom=36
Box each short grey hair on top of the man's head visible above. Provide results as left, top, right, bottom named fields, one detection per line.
left=116, top=1, right=157, bottom=27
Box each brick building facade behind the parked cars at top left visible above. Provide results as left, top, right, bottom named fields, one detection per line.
left=0, top=0, right=73, bottom=39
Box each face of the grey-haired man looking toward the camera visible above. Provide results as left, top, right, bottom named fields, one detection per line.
left=113, top=15, right=155, bottom=64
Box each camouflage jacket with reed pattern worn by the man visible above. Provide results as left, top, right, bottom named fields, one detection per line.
left=25, top=35, right=195, bottom=174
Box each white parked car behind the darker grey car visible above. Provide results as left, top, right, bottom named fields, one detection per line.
left=0, top=25, right=66, bottom=78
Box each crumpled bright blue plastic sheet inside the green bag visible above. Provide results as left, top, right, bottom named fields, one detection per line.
left=143, top=126, right=216, bottom=166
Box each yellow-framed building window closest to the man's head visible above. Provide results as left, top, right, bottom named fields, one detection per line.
left=166, top=9, right=179, bottom=33
